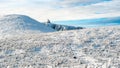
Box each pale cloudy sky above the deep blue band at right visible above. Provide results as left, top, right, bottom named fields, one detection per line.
left=0, top=0, right=120, bottom=21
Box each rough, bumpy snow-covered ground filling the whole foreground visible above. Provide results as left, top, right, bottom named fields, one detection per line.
left=0, top=27, right=120, bottom=68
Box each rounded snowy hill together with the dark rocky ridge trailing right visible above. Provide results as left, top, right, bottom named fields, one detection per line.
left=0, top=14, right=82, bottom=34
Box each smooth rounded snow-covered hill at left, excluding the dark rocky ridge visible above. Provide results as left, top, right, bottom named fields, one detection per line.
left=0, top=14, right=55, bottom=34
